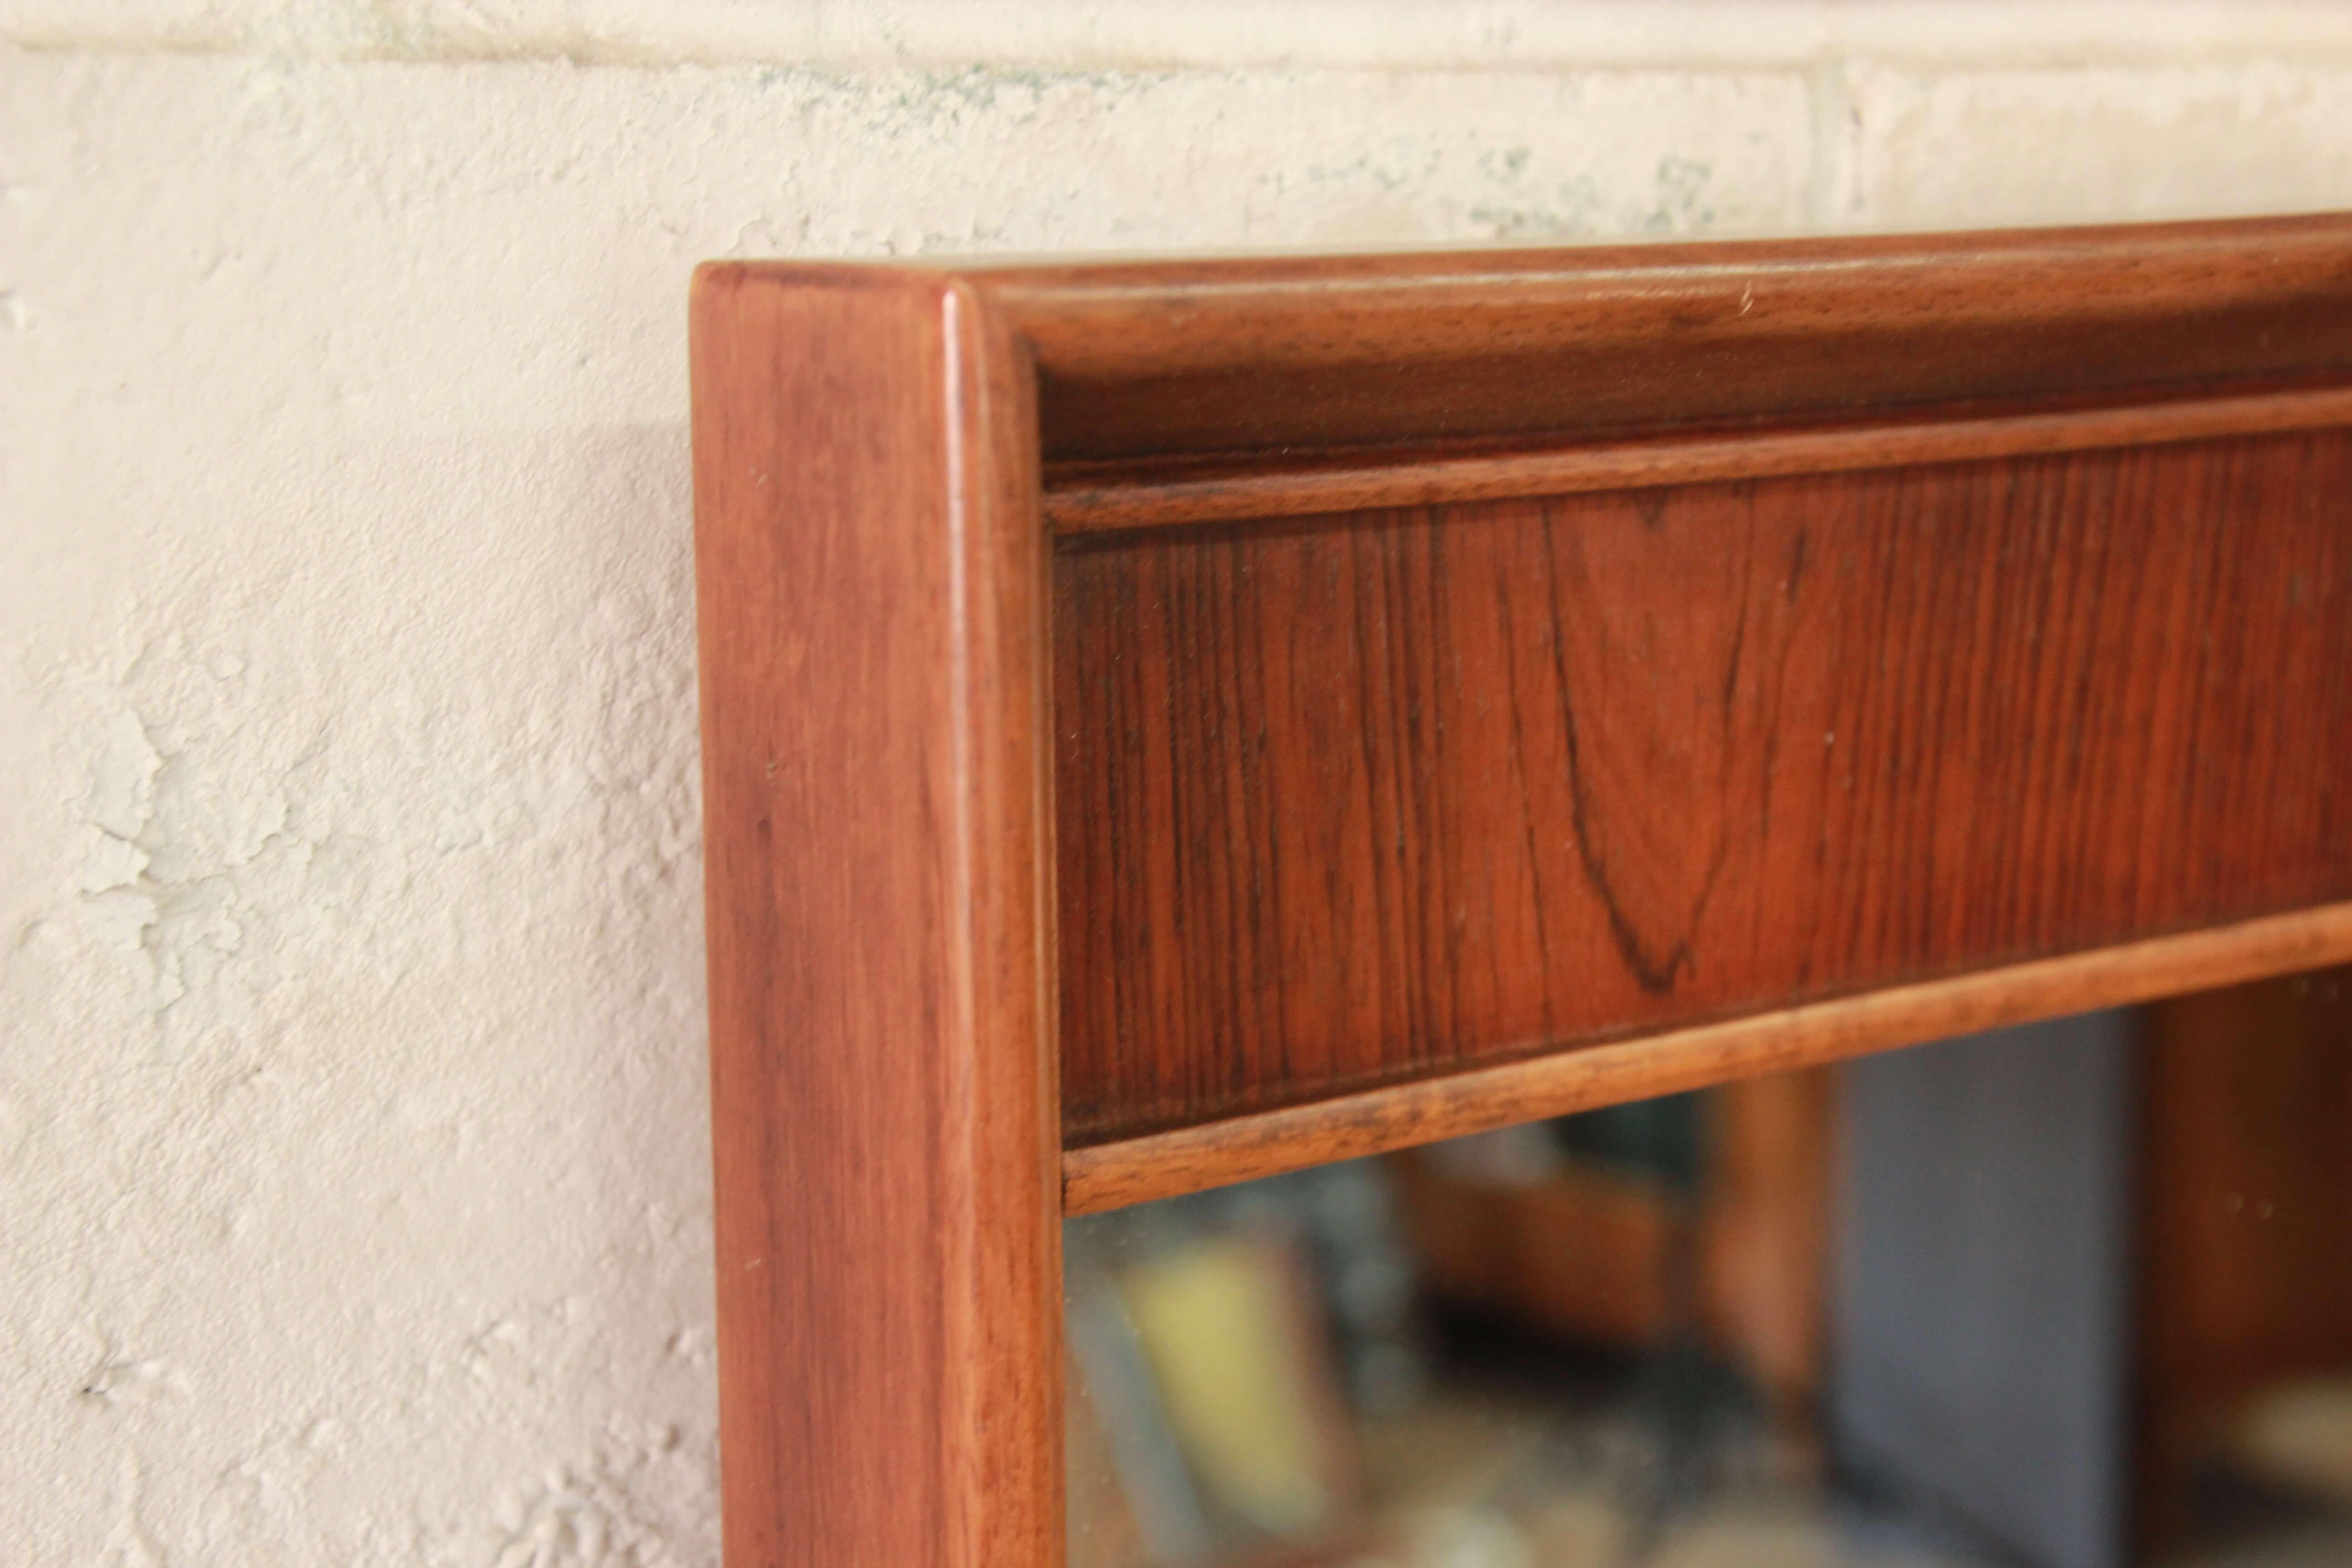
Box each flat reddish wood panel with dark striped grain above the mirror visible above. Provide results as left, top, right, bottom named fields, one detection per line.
left=1054, top=430, right=2352, bottom=1142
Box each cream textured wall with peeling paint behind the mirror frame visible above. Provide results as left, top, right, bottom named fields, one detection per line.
left=14, top=0, right=2352, bottom=1568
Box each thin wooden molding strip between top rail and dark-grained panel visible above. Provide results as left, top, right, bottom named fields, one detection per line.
left=1044, top=386, right=2352, bottom=536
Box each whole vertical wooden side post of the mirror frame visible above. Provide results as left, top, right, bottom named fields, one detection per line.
left=694, top=268, right=1063, bottom=1568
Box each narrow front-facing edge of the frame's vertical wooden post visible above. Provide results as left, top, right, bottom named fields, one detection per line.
left=941, top=280, right=1065, bottom=1568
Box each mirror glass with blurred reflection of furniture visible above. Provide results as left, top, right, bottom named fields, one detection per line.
left=1065, top=971, right=2352, bottom=1568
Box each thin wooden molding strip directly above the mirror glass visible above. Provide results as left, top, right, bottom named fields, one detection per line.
left=1061, top=903, right=2352, bottom=1215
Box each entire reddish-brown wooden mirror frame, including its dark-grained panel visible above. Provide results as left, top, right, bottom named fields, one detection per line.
left=691, top=216, right=2352, bottom=1568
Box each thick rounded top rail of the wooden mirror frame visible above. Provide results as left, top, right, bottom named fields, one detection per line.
left=974, top=214, right=2352, bottom=461
